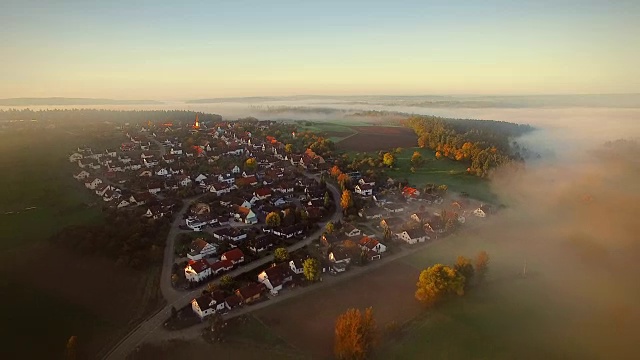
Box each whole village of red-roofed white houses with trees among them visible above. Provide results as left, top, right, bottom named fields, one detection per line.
left=69, top=117, right=493, bottom=329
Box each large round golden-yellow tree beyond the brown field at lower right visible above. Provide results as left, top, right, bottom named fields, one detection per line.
left=415, top=264, right=465, bottom=306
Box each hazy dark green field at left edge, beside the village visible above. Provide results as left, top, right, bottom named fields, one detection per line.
left=0, top=129, right=102, bottom=251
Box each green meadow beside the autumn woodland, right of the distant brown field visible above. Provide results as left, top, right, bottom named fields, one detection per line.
left=387, top=147, right=496, bottom=202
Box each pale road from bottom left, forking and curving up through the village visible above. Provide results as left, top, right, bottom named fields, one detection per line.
left=104, top=173, right=342, bottom=359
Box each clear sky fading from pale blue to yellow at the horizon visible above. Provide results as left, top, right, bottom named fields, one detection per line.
left=0, top=0, right=640, bottom=100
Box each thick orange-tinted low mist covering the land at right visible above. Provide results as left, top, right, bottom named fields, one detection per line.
left=460, top=137, right=640, bottom=359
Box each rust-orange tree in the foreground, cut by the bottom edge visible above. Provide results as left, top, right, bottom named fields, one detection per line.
left=334, top=307, right=378, bottom=360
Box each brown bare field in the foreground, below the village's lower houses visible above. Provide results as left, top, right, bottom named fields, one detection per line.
left=255, top=261, right=422, bottom=359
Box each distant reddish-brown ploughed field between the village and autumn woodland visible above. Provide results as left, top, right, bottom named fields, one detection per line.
left=338, top=126, right=416, bottom=151
